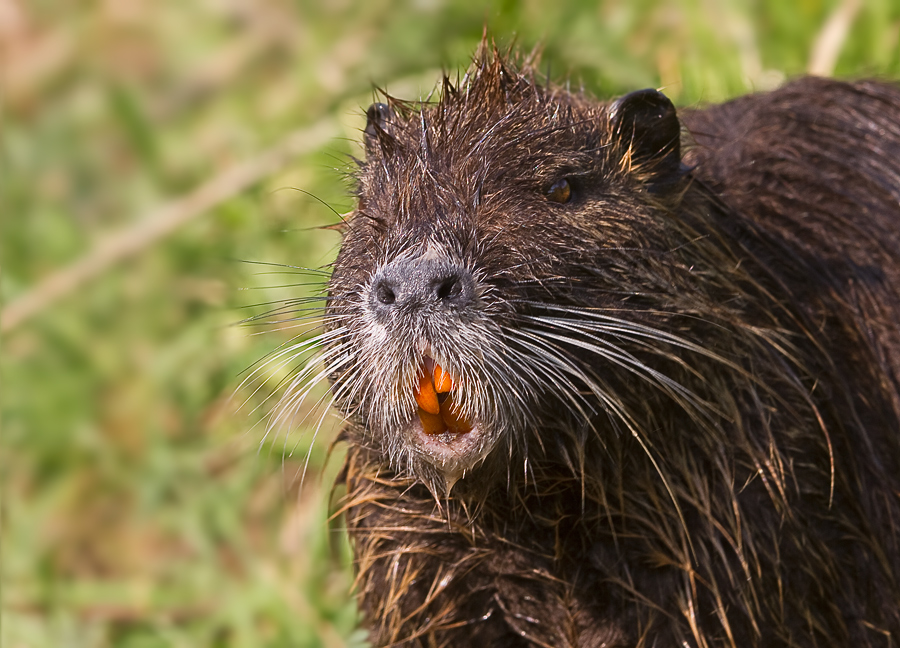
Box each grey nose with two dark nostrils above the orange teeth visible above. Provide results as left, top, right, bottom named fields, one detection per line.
left=371, top=258, right=475, bottom=315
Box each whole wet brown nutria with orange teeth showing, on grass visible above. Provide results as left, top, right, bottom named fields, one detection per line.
left=308, top=48, right=900, bottom=648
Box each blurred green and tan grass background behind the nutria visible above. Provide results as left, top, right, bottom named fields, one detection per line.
left=0, top=0, right=900, bottom=648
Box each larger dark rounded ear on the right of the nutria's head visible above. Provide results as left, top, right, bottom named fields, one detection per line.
left=609, top=89, right=681, bottom=183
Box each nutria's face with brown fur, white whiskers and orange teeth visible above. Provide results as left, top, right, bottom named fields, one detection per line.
left=326, top=64, right=678, bottom=492
